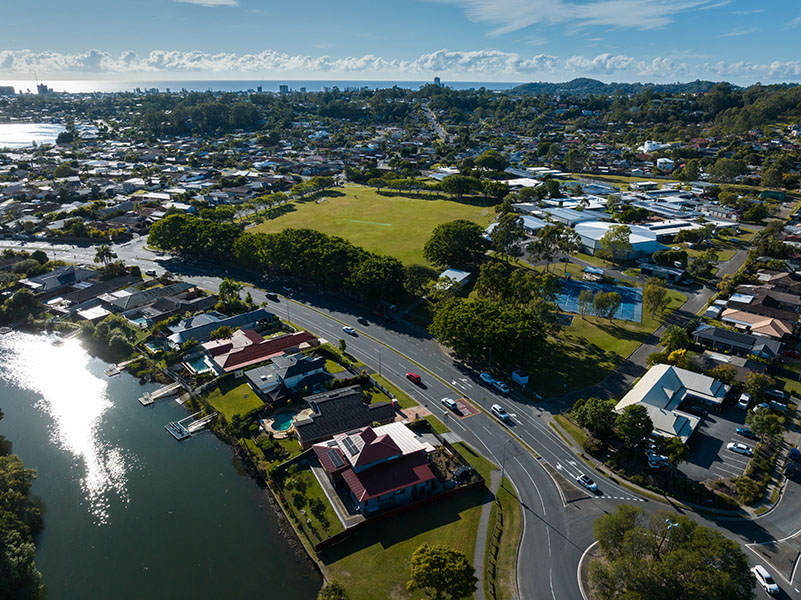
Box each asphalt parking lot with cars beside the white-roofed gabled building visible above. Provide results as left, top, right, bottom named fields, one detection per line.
left=679, top=406, right=756, bottom=481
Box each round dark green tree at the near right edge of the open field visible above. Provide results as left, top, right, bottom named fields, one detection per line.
left=423, top=219, right=487, bottom=269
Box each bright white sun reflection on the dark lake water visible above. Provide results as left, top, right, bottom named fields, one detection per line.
left=0, top=333, right=129, bottom=523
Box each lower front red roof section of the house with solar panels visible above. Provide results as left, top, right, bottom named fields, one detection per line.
left=342, top=450, right=434, bottom=502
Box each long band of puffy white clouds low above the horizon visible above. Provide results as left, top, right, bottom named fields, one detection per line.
left=0, top=49, right=801, bottom=83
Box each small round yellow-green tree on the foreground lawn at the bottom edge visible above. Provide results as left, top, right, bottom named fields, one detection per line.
left=406, top=544, right=478, bottom=600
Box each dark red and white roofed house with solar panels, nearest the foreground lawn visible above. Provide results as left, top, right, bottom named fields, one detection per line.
left=312, top=422, right=437, bottom=515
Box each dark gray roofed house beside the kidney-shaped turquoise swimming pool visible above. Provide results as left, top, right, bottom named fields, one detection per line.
left=295, top=385, right=395, bottom=448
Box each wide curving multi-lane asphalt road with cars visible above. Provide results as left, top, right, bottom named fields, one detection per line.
left=9, top=239, right=801, bottom=600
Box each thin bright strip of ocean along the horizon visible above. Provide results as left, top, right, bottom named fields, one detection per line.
left=0, top=79, right=523, bottom=94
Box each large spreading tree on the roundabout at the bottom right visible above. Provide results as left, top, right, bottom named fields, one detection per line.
left=589, top=504, right=754, bottom=600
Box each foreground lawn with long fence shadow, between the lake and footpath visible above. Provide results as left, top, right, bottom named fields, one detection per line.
left=319, top=487, right=492, bottom=600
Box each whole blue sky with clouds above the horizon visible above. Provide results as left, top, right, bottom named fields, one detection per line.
left=0, top=0, right=801, bottom=84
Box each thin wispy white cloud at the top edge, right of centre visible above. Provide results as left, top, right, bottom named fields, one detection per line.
left=429, top=0, right=726, bottom=35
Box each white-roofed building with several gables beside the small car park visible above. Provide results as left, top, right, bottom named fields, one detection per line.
left=615, top=365, right=731, bottom=443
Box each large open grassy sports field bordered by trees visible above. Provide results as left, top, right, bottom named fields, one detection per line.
left=255, top=184, right=495, bottom=264
